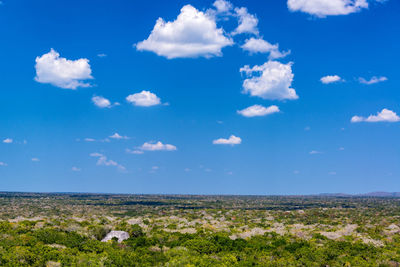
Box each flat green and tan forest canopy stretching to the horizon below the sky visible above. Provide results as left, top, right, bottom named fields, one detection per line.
left=0, top=193, right=400, bottom=266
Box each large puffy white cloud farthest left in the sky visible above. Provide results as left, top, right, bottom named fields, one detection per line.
left=35, top=49, right=93, bottom=90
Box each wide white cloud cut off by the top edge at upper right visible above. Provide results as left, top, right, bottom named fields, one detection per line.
left=287, top=0, right=368, bottom=18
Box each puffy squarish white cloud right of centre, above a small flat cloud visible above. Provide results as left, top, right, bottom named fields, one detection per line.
left=240, top=61, right=298, bottom=100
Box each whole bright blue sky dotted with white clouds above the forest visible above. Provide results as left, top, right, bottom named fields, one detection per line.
left=0, top=0, right=400, bottom=194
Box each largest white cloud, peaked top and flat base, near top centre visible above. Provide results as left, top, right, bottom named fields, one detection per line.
left=136, top=5, right=233, bottom=59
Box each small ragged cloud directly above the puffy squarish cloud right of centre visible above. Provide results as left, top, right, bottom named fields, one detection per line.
left=241, top=37, right=290, bottom=59
